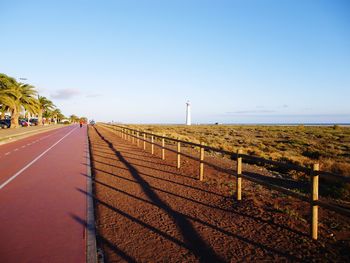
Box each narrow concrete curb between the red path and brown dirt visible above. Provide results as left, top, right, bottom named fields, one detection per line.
left=86, top=129, right=97, bottom=263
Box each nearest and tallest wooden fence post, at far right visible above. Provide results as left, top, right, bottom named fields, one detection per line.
left=311, top=163, right=320, bottom=240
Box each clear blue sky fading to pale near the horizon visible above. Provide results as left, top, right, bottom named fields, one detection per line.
left=0, top=0, right=350, bottom=123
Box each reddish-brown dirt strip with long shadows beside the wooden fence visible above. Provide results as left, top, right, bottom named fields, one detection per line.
left=89, top=126, right=350, bottom=262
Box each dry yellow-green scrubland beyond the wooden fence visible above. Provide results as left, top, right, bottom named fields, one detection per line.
left=125, top=125, right=350, bottom=199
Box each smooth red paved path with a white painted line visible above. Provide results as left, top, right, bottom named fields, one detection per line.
left=0, top=125, right=88, bottom=262
